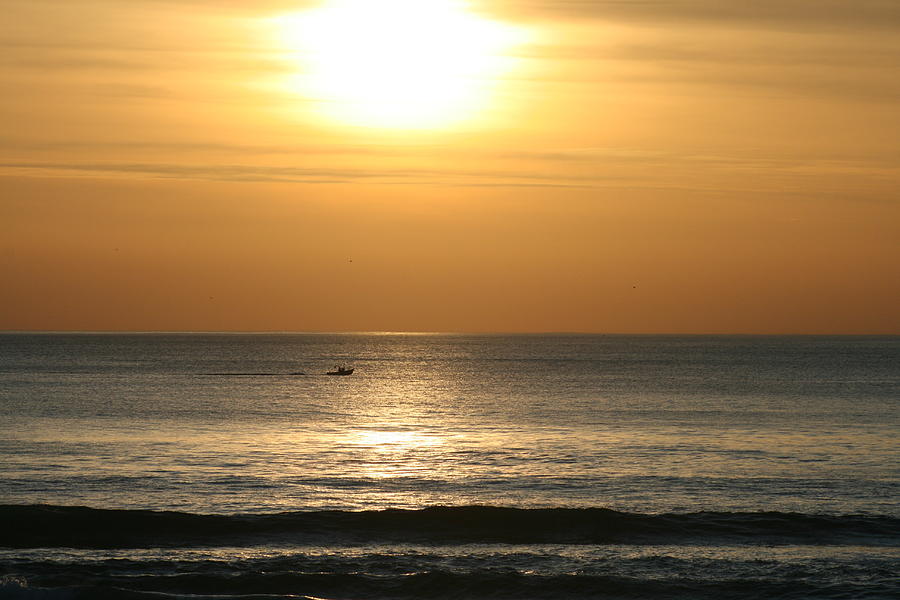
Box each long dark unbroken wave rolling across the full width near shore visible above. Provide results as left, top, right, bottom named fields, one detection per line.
left=0, top=505, right=900, bottom=548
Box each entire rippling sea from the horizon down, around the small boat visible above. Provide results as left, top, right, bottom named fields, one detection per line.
left=0, top=334, right=900, bottom=599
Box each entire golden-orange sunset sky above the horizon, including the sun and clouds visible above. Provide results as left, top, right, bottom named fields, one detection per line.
left=0, top=0, right=900, bottom=334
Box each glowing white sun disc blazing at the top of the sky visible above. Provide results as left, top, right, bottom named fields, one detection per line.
left=278, top=0, right=522, bottom=129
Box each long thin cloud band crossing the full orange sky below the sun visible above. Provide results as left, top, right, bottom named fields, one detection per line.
left=0, top=148, right=900, bottom=192
